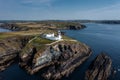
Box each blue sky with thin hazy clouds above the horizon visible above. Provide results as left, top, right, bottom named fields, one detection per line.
left=0, top=0, right=120, bottom=20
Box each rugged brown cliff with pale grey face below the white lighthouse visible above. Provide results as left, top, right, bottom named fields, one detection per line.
left=19, top=41, right=91, bottom=80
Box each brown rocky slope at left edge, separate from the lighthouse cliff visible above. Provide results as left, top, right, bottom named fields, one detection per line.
left=0, top=36, right=30, bottom=71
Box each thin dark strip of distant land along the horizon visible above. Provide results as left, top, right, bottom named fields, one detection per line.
left=0, top=20, right=120, bottom=24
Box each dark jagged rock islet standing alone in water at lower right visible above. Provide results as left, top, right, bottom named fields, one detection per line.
left=85, top=53, right=112, bottom=80
